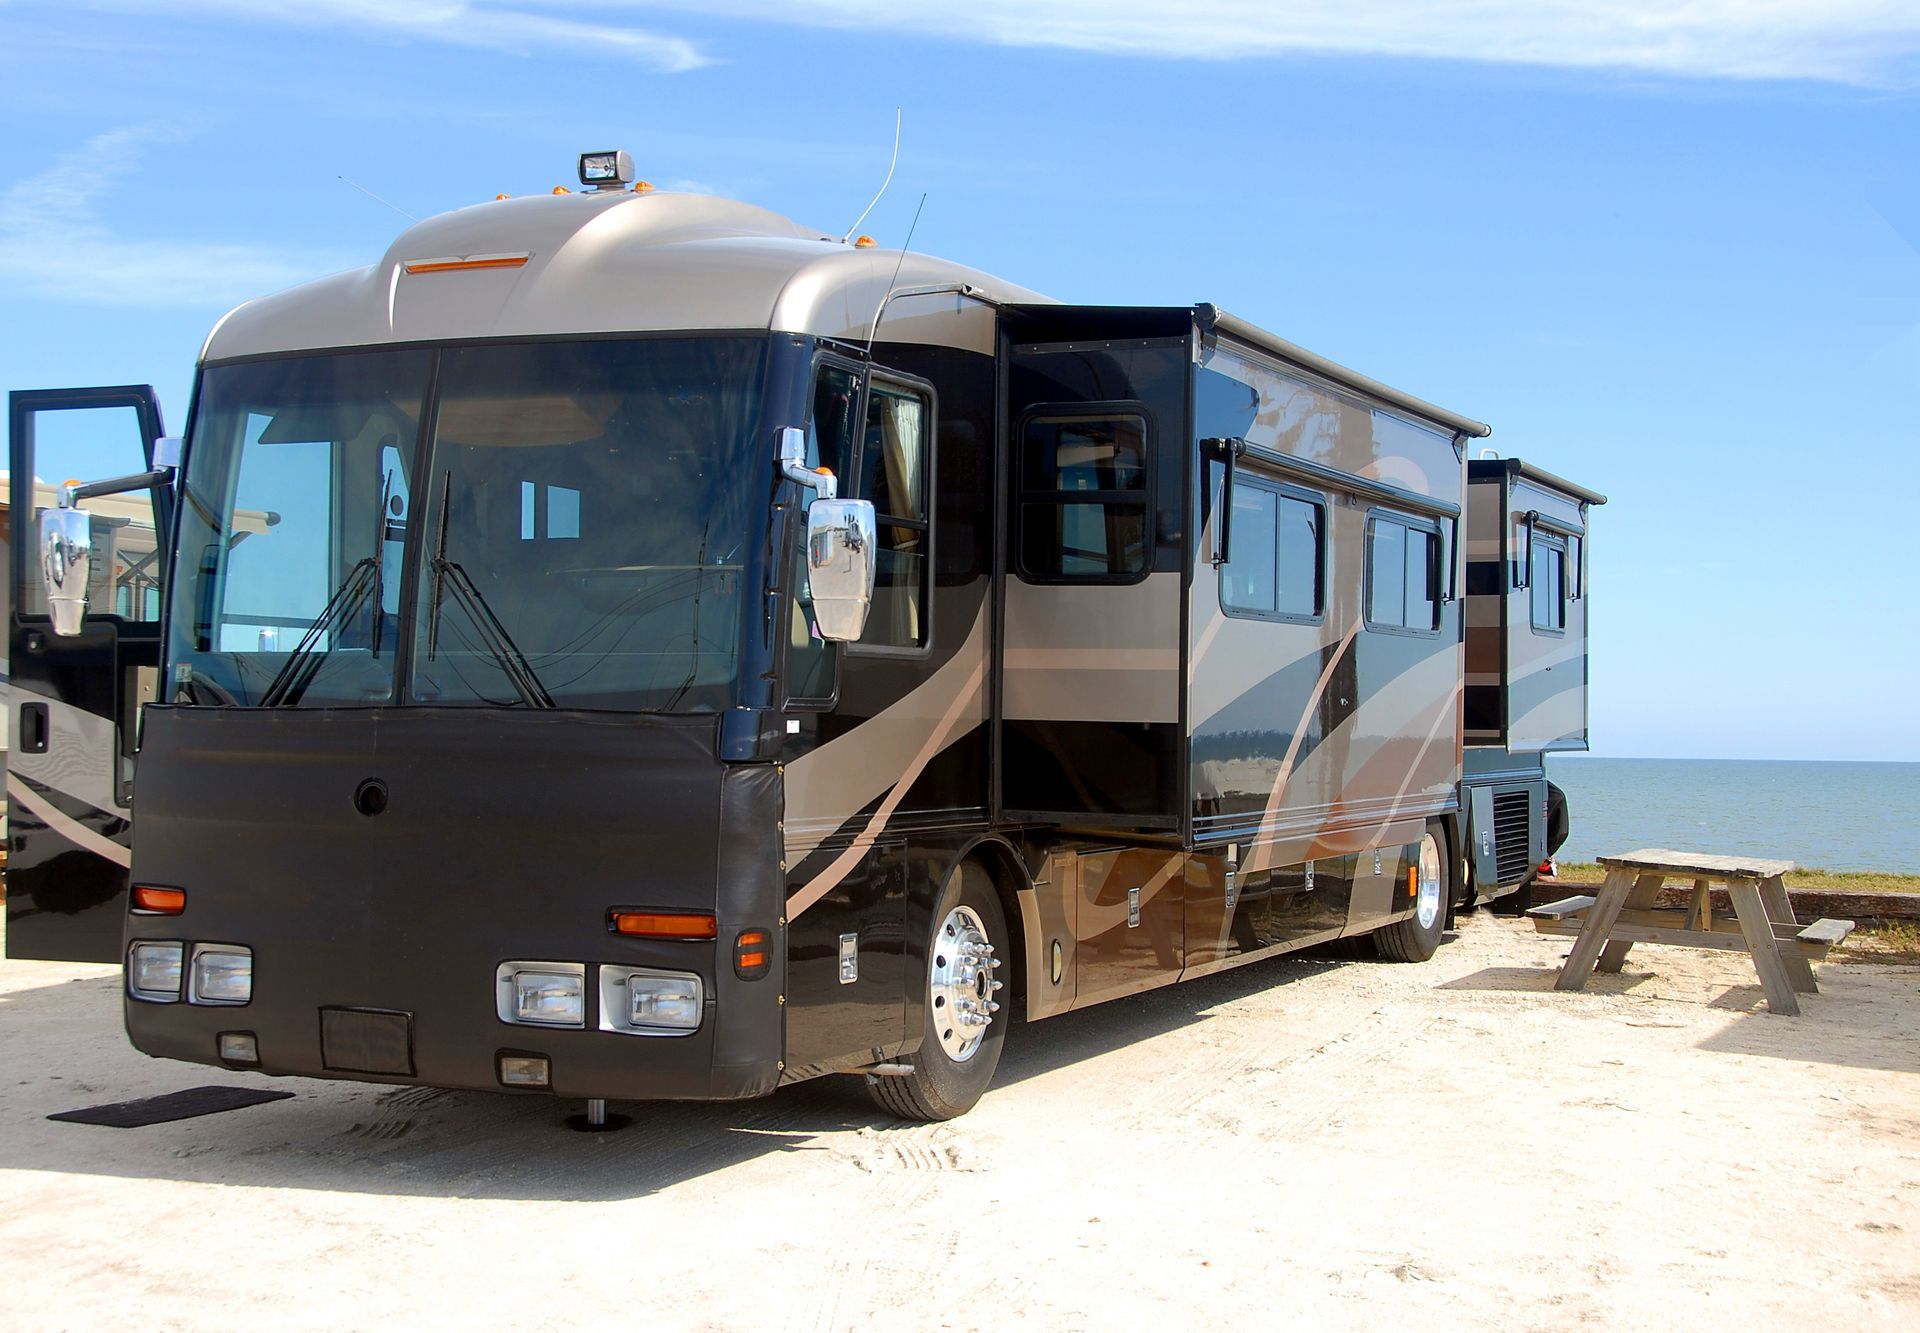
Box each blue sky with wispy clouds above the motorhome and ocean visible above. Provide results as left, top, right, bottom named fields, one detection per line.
left=0, top=0, right=1920, bottom=761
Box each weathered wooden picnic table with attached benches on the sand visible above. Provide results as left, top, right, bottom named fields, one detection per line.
left=1528, top=849, right=1853, bottom=1014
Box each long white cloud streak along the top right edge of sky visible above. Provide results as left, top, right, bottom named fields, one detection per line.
left=622, top=0, right=1920, bottom=86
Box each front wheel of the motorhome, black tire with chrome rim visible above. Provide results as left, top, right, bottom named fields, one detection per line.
left=866, top=860, right=1010, bottom=1120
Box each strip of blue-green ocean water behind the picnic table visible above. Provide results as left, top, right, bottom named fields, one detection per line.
left=1548, top=755, right=1920, bottom=874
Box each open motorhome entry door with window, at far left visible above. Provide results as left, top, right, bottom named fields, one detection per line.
left=6, top=384, right=173, bottom=962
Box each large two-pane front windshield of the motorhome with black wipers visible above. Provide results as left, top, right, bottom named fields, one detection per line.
left=169, top=338, right=764, bottom=713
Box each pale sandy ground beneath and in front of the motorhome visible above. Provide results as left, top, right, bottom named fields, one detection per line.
left=0, top=912, right=1920, bottom=1331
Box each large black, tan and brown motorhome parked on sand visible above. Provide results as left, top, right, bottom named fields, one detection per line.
left=8, top=154, right=1584, bottom=1120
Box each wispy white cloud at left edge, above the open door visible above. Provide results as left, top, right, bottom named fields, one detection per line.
left=0, top=127, right=346, bottom=307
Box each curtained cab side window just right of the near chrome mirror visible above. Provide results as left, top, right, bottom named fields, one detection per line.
left=856, top=378, right=933, bottom=647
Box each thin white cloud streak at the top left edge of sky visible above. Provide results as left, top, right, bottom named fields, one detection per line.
left=26, top=0, right=710, bottom=73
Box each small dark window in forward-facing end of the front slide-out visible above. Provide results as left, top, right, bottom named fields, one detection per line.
left=1020, top=411, right=1150, bottom=584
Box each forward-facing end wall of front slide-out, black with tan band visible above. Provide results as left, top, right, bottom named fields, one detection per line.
left=995, top=305, right=1194, bottom=834
